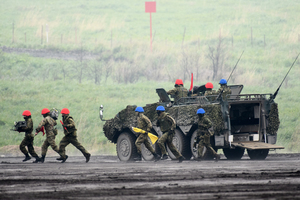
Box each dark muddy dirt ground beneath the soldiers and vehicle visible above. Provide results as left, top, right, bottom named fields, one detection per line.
left=0, top=154, right=300, bottom=199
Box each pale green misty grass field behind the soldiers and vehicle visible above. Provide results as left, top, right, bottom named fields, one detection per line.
left=0, top=0, right=300, bottom=153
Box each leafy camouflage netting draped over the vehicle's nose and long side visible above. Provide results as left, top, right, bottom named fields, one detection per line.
left=103, top=103, right=224, bottom=143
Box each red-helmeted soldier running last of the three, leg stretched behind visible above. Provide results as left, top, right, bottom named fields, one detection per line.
left=56, top=108, right=91, bottom=163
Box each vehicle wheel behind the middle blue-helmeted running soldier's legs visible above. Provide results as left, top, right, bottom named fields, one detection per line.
left=167, top=129, right=192, bottom=160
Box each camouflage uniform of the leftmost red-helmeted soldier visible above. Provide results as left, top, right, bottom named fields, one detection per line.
left=20, top=117, right=38, bottom=158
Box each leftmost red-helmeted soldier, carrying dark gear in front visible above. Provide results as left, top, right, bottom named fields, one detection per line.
left=20, top=110, right=40, bottom=163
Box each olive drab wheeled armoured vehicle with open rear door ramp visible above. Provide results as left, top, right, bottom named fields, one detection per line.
left=100, top=85, right=284, bottom=161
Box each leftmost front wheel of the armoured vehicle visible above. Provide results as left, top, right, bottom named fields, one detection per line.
left=117, top=132, right=138, bottom=161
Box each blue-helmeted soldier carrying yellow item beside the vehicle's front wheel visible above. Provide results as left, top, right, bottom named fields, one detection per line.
left=134, top=107, right=160, bottom=161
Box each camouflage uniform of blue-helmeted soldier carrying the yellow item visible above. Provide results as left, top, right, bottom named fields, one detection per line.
left=135, top=113, right=155, bottom=154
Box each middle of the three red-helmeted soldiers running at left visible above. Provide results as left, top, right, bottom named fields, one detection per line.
left=35, top=108, right=59, bottom=163
